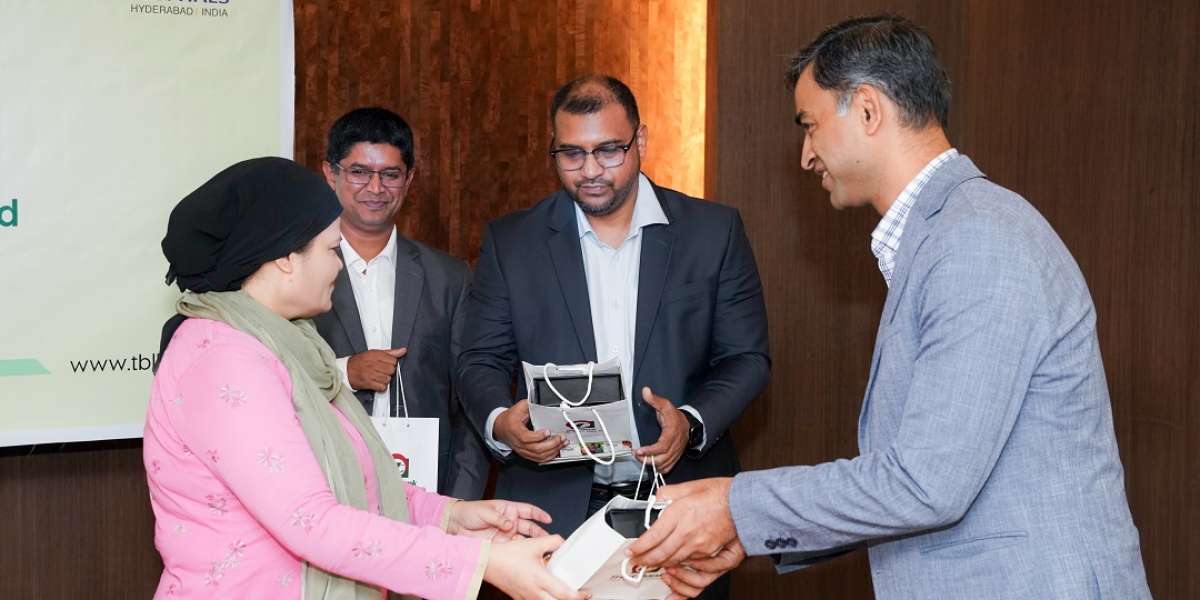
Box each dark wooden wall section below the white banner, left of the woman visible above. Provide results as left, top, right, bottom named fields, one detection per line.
left=0, top=440, right=162, bottom=599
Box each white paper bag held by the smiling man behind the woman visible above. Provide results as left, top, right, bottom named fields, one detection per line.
left=371, top=368, right=439, bottom=491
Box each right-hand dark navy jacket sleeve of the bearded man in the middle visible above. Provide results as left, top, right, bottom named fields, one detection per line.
left=686, top=211, right=770, bottom=452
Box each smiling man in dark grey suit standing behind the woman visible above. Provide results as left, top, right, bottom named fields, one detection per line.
left=313, top=108, right=488, bottom=499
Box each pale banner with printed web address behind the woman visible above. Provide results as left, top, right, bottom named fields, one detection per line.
left=0, top=0, right=295, bottom=445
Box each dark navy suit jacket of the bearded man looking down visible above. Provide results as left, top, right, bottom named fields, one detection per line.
left=458, top=180, right=770, bottom=535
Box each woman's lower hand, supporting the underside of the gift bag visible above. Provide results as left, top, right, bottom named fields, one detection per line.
left=480, top=537, right=592, bottom=600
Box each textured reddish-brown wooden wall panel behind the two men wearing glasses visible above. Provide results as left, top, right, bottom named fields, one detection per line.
left=295, top=0, right=707, bottom=258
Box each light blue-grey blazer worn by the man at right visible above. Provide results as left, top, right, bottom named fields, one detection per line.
left=731, top=156, right=1150, bottom=600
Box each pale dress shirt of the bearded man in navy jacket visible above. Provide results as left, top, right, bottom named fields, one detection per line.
left=486, top=174, right=703, bottom=484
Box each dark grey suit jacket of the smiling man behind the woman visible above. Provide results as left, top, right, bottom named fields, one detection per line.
left=313, top=235, right=490, bottom=499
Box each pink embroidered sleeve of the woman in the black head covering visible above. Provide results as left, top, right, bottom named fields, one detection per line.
left=173, top=343, right=487, bottom=599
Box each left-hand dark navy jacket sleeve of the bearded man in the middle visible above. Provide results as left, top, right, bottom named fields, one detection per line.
left=458, top=224, right=517, bottom=460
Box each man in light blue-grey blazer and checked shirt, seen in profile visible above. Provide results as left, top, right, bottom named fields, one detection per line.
left=631, top=17, right=1150, bottom=600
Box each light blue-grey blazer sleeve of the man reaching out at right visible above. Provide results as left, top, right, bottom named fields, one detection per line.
left=730, top=223, right=1051, bottom=554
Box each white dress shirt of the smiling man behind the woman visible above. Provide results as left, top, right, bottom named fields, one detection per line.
left=337, top=227, right=396, bottom=416
